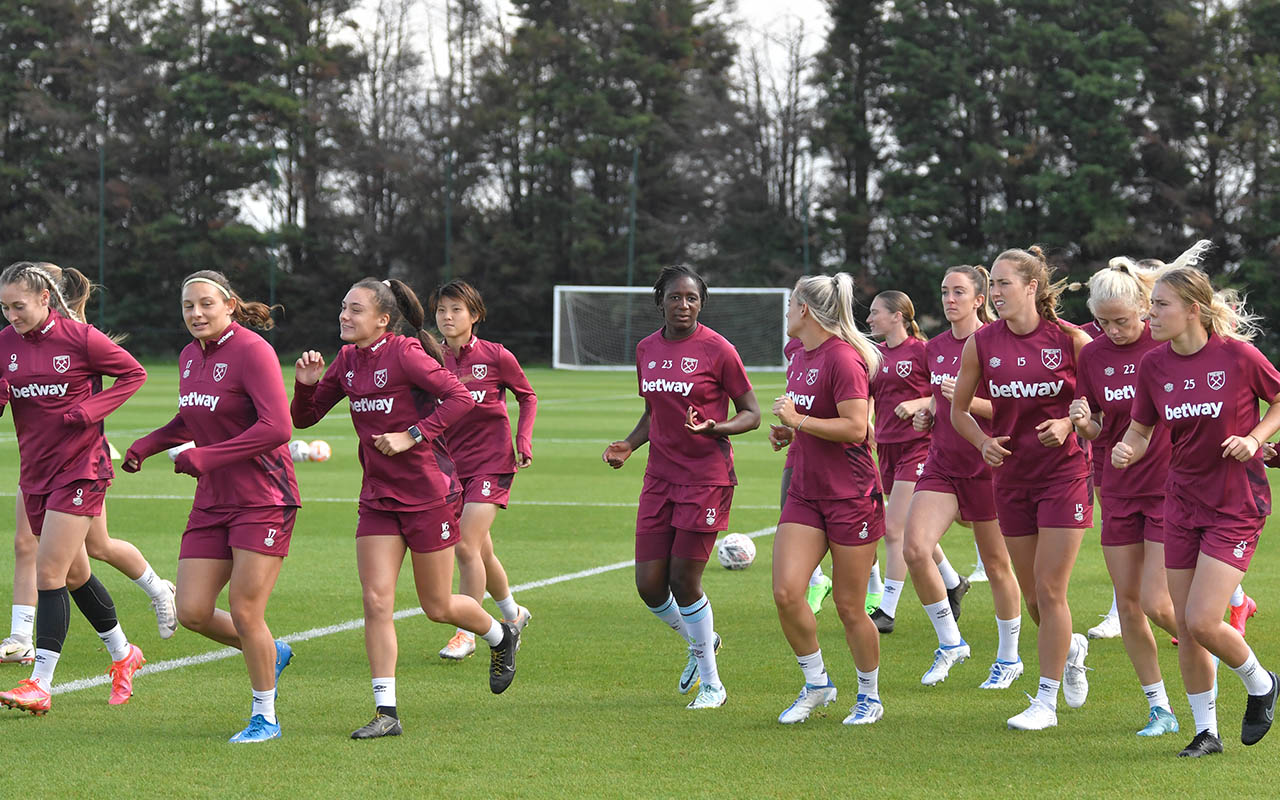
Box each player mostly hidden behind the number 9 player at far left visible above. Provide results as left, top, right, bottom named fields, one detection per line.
left=0, top=261, right=178, bottom=663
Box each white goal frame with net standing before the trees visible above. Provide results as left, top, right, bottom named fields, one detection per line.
left=552, top=285, right=791, bottom=371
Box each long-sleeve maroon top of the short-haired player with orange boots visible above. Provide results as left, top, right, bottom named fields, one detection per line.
left=444, top=337, right=538, bottom=477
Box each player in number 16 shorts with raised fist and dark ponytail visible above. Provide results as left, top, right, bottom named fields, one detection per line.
left=291, top=278, right=520, bottom=739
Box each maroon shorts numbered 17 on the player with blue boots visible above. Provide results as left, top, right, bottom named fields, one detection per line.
left=178, top=506, right=298, bottom=561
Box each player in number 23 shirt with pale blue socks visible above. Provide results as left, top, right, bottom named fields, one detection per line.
left=602, top=265, right=757, bottom=709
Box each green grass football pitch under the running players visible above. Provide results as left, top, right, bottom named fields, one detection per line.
left=0, top=364, right=1280, bottom=797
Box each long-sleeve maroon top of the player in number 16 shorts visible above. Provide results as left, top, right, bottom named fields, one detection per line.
left=289, top=334, right=475, bottom=511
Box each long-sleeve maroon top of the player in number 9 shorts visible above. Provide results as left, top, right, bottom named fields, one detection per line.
left=0, top=310, right=147, bottom=494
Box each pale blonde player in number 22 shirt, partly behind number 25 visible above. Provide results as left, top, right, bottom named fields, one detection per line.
left=1070, top=257, right=1178, bottom=736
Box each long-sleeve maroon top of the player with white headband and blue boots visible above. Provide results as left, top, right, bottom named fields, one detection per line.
left=131, top=323, right=301, bottom=509
